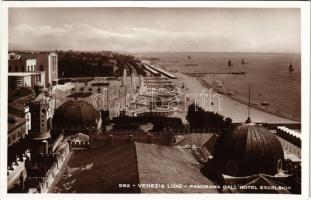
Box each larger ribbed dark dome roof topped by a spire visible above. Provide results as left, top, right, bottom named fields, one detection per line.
left=214, top=123, right=284, bottom=176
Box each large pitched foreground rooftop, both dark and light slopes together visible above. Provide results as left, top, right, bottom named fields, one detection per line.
left=50, top=141, right=217, bottom=193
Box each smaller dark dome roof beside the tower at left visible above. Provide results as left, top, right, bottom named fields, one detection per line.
left=53, top=100, right=99, bottom=132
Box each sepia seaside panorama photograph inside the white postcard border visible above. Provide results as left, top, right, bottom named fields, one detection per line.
left=1, top=1, right=309, bottom=196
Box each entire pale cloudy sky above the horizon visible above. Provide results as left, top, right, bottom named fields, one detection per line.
left=8, top=8, right=300, bottom=53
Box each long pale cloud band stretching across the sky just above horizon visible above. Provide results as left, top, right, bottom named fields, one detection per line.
left=9, top=23, right=300, bottom=52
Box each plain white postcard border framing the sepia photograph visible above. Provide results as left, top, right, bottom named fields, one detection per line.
left=0, top=1, right=310, bottom=200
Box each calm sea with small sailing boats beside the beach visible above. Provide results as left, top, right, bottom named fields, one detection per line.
left=135, top=52, right=301, bottom=121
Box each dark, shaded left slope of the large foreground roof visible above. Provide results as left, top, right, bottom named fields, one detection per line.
left=49, top=144, right=139, bottom=193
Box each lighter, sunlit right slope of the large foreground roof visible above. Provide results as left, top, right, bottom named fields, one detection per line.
left=136, top=143, right=218, bottom=193
